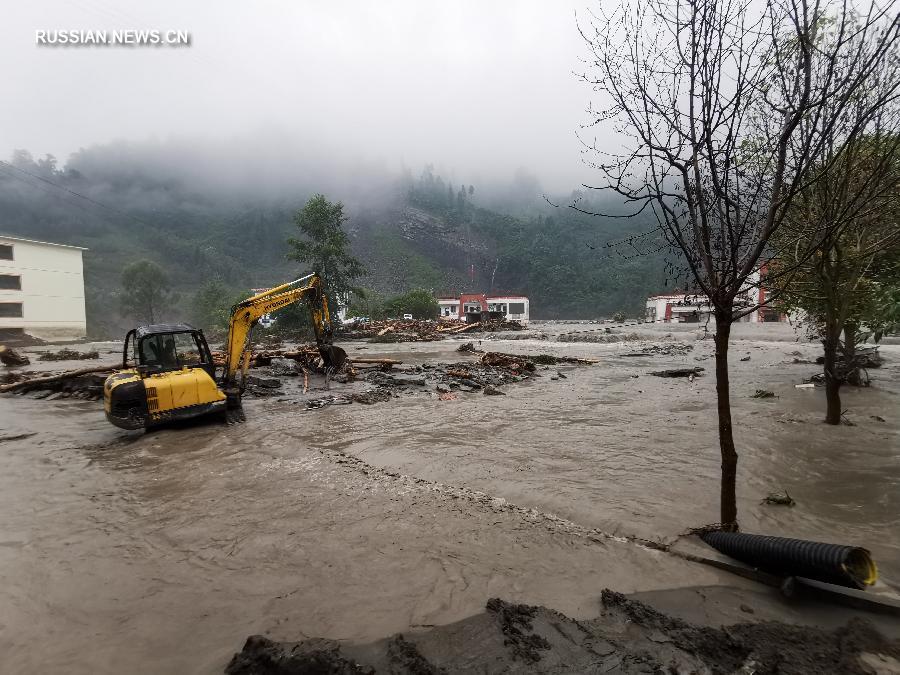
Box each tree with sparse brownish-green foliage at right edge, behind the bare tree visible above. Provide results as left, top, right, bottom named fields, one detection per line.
left=773, top=134, right=900, bottom=424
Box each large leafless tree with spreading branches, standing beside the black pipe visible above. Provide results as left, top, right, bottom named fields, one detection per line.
left=580, top=0, right=900, bottom=530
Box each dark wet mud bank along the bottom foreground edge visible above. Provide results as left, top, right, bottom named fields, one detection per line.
left=225, top=590, right=900, bottom=675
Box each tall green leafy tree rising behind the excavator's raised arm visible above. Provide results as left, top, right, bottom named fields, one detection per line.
left=288, top=194, right=366, bottom=314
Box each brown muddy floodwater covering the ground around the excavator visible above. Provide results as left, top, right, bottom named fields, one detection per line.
left=0, top=324, right=900, bottom=673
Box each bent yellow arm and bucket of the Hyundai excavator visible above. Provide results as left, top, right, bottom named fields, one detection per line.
left=222, top=273, right=347, bottom=408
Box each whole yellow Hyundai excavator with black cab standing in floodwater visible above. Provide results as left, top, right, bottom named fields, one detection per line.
left=103, top=273, right=347, bottom=429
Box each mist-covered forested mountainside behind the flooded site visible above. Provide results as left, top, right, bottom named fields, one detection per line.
left=0, top=143, right=664, bottom=336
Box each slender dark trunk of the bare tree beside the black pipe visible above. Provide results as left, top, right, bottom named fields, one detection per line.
left=716, top=310, right=738, bottom=532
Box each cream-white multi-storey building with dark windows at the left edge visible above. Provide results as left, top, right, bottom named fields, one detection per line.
left=0, top=234, right=87, bottom=340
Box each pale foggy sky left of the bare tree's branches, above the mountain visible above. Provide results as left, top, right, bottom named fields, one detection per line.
left=0, top=0, right=592, bottom=189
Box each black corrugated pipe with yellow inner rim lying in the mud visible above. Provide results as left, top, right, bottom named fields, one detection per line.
left=700, top=532, right=878, bottom=588
